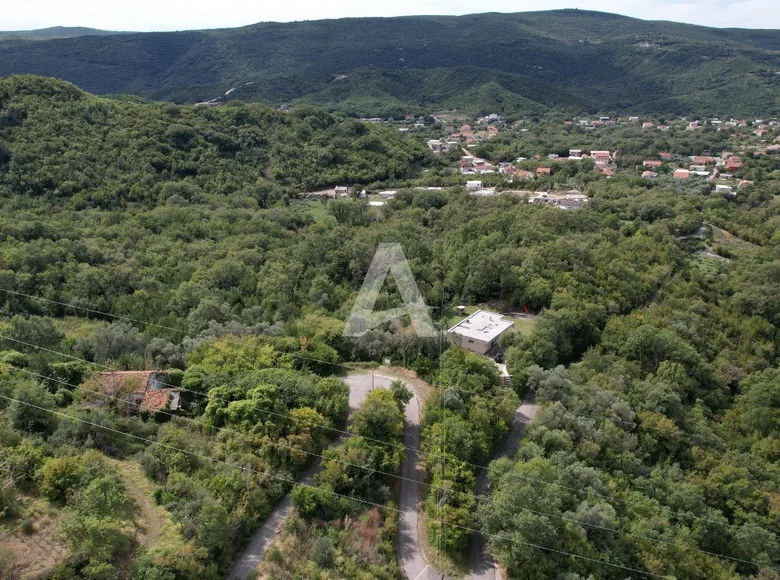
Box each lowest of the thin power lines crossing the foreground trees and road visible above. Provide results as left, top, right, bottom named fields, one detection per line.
left=0, top=394, right=666, bottom=578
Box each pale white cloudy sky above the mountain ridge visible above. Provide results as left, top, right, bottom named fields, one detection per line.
left=0, top=0, right=780, bottom=31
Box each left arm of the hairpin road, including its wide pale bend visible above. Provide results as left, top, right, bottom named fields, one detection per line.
left=228, top=373, right=394, bottom=580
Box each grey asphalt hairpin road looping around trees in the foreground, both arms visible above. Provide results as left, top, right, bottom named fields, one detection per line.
left=228, top=373, right=439, bottom=580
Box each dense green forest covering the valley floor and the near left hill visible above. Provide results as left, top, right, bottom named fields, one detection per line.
left=0, top=77, right=780, bottom=580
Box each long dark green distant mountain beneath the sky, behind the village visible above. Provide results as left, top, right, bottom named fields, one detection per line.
left=0, top=10, right=780, bottom=116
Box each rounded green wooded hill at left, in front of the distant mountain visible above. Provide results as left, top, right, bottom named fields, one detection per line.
left=0, top=76, right=430, bottom=207
